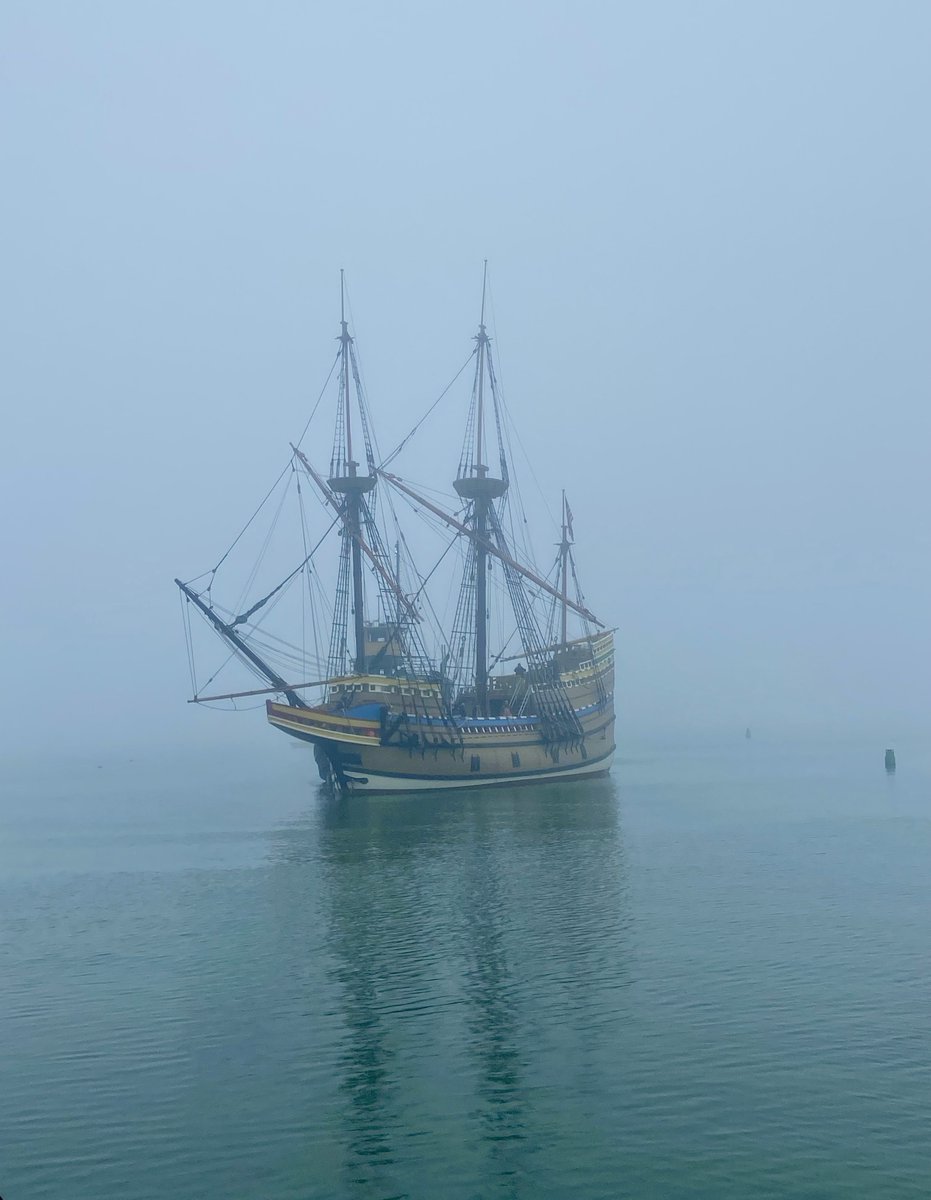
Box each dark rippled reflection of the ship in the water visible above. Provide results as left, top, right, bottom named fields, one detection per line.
left=268, top=780, right=629, bottom=1196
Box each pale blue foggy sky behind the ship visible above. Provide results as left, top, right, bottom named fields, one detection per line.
left=0, top=0, right=931, bottom=752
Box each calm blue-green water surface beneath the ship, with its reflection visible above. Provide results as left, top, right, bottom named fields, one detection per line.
left=0, top=737, right=931, bottom=1200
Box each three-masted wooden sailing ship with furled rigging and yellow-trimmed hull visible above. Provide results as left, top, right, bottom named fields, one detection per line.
left=175, top=268, right=614, bottom=793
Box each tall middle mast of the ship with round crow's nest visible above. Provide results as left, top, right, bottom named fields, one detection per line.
left=454, top=259, right=507, bottom=716
